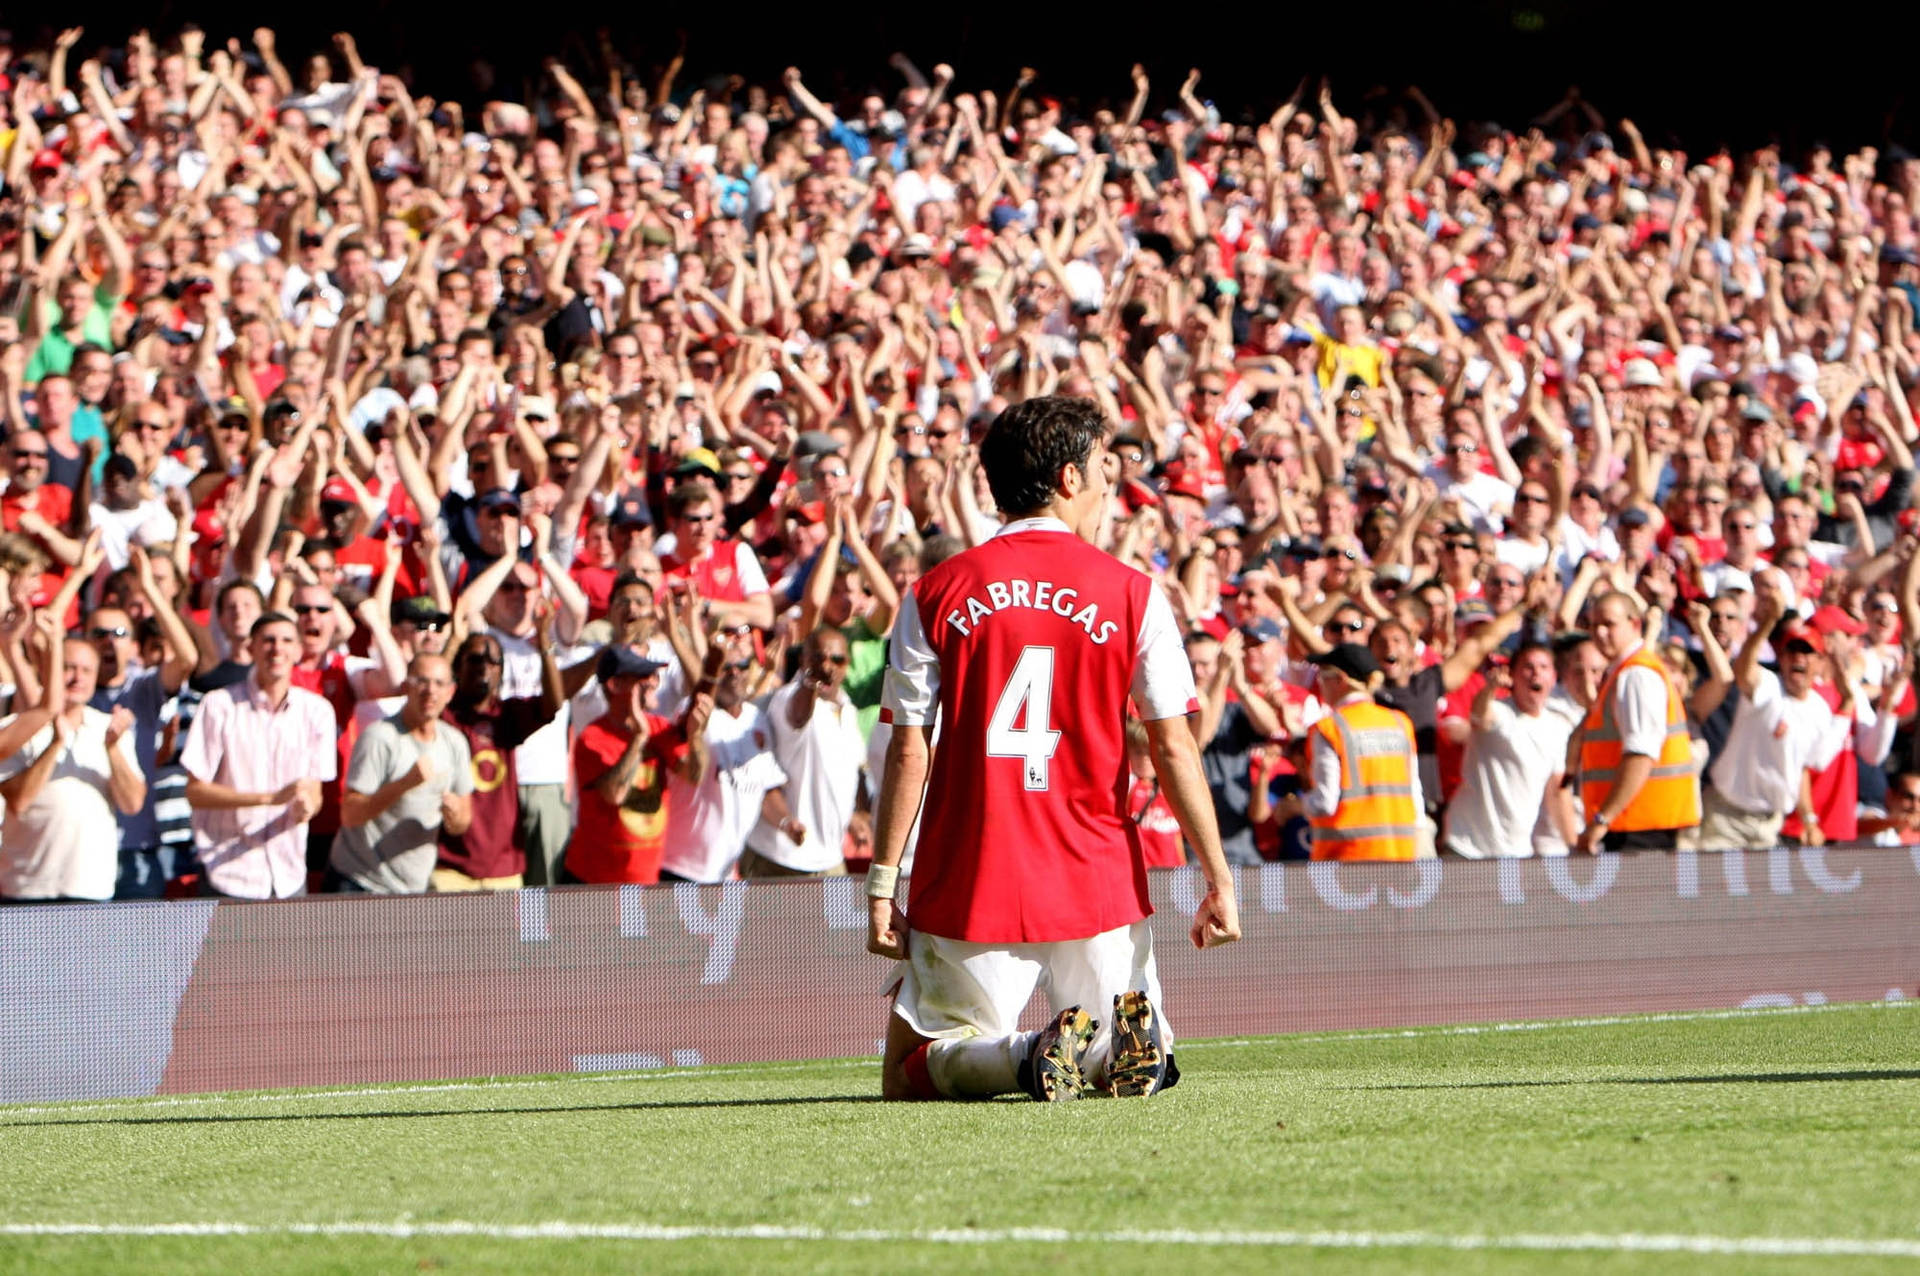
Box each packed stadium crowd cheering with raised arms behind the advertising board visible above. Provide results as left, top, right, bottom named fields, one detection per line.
left=0, top=29, right=1920, bottom=900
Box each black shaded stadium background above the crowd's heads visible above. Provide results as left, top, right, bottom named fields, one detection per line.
left=10, top=0, right=1920, bottom=154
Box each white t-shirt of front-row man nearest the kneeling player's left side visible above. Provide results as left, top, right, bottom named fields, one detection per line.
left=747, top=683, right=866, bottom=873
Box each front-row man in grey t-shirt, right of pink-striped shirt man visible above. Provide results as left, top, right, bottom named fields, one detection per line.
left=326, top=654, right=474, bottom=894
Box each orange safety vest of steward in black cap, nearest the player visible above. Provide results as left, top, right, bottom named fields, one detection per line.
left=1313, top=700, right=1421, bottom=860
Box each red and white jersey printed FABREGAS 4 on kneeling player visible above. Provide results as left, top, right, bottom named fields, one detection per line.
left=881, top=518, right=1198, bottom=944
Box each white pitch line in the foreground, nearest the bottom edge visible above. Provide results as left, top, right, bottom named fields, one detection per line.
left=0, top=1220, right=1920, bottom=1259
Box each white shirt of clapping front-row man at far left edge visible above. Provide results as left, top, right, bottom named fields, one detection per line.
left=0, top=708, right=140, bottom=900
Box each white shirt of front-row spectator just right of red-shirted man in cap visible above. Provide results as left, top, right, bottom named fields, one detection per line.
left=660, top=702, right=787, bottom=883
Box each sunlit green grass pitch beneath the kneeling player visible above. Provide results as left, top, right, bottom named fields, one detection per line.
left=0, top=1005, right=1920, bottom=1276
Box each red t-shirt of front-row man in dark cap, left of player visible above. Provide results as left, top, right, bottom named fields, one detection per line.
left=566, top=714, right=687, bottom=885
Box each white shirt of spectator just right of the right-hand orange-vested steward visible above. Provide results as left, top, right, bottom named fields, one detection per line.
left=1711, top=670, right=1853, bottom=817
